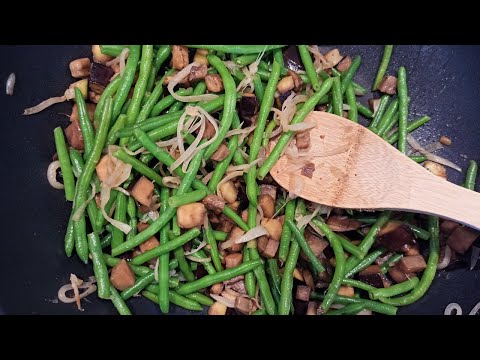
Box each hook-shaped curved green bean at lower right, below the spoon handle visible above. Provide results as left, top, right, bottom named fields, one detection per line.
left=380, top=216, right=440, bottom=306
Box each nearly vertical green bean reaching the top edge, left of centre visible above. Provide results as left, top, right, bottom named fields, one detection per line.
left=124, top=45, right=153, bottom=125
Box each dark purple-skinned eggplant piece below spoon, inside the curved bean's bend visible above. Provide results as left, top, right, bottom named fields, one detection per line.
left=377, top=220, right=416, bottom=252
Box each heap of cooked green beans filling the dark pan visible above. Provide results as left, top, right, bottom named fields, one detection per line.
left=43, top=45, right=470, bottom=315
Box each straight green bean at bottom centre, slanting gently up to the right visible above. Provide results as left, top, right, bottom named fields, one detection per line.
left=177, top=259, right=262, bottom=295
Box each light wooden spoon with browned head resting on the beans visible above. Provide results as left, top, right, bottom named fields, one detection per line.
left=270, top=111, right=480, bottom=230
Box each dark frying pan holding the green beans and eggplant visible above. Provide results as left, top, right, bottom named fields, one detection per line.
left=0, top=45, right=480, bottom=314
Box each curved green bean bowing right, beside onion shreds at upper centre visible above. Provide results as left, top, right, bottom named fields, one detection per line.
left=203, top=55, right=237, bottom=160
